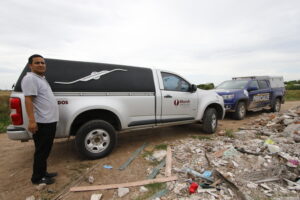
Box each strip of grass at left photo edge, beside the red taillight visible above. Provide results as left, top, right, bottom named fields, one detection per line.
left=0, top=91, right=10, bottom=133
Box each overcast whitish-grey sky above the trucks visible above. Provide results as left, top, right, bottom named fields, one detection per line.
left=0, top=0, right=300, bottom=89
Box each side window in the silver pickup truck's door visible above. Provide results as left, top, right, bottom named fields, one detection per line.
left=161, top=72, right=189, bottom=92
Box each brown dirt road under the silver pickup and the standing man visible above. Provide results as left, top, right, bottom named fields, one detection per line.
left=0, top=101, right=300, bottom=200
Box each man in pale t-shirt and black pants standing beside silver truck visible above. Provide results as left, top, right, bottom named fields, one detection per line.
left=21, top=54, right=58, bottom=184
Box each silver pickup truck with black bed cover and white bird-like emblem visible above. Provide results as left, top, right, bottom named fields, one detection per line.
left=7, top=59, right=225, bottom=159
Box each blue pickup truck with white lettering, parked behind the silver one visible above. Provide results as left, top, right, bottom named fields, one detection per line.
left=215, top=76, right=285, bottom=120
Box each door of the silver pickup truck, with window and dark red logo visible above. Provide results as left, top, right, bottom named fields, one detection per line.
left=161, top=72, right=198, bottom=123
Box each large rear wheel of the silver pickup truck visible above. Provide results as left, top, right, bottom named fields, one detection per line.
left=75, top=120, right=117, bottom=159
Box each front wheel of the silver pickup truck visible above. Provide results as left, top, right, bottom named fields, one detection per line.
left=203, top=108, right=218, bottom=133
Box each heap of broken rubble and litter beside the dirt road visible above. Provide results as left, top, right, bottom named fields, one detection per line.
left=161, top=106, right=300, bottom=200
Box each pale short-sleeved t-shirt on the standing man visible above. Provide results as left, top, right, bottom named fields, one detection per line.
left=21, top=72, right=58, bottom=123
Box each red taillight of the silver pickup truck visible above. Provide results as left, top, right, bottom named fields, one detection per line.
left=9, top=97, right=23, bottom=125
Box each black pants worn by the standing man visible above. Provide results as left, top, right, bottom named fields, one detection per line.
left=31, top=122, right=56, bottom=182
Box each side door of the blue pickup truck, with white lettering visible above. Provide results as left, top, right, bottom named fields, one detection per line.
left=249, top=80, right=271, bottom=109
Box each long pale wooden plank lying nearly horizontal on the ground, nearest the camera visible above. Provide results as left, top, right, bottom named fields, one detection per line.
left=70, top=176, right=178, bottom=192
